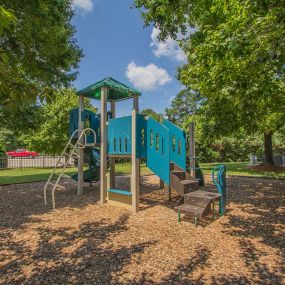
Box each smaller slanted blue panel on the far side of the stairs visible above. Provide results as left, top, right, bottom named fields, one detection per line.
left=163, top=120, right=186, bottom=171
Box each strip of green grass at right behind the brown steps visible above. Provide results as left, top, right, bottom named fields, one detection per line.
left=200, top=162, right=285, bottom=179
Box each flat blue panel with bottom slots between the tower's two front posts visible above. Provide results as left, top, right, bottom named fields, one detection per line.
left=108, top=116, right=132, bottom=154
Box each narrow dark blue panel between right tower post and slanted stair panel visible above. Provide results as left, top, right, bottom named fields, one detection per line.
left=137, top=114, right=147, bottom=158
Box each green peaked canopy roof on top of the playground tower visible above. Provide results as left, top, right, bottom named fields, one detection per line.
left=77, top=77, right=141, bottom=101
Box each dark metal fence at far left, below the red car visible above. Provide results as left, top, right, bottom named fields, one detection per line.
left=0, top=155, right=72, bottom=170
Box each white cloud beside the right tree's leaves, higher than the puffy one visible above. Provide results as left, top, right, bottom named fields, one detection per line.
left=150, top=27, right=186, bottom=61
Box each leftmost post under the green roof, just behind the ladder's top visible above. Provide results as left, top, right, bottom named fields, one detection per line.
left=77, top=95, right=84, bottom=196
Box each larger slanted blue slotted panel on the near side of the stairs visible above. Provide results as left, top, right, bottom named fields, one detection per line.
left=147, top=118, right=170, bottom=185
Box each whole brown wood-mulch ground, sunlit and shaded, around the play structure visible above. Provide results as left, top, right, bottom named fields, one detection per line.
left=0, top=173, right=285, bottom=285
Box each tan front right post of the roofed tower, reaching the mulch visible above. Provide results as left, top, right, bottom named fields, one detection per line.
left=131, top=95, right=140, bottom=213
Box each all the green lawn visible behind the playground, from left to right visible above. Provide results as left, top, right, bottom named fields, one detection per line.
left=0, top=162, right=285, bottom=185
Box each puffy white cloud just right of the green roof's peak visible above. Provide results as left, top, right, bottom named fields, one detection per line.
left=125, top=61, right=172, bottom=90
